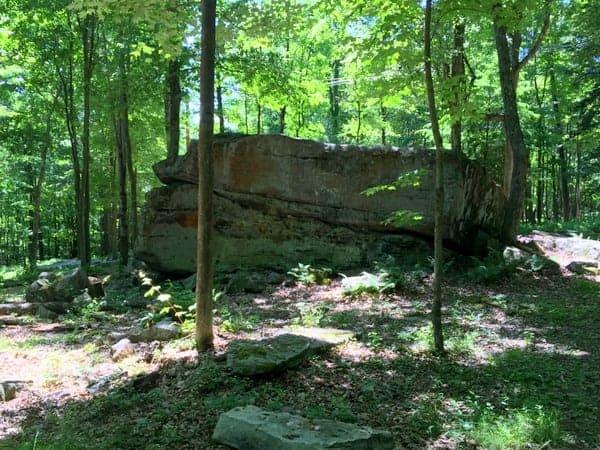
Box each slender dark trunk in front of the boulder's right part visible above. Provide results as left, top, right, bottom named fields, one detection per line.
left=424, top=0, right=444, bottom=354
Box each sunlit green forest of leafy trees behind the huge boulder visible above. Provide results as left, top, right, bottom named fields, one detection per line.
left=0, top=0, right=600, bottom=267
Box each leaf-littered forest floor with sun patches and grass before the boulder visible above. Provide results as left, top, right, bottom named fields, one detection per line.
left=0, top=246, right=600, bottom=450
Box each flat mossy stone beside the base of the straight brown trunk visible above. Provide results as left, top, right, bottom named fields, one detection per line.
left=227, top=334, right=332, bottom=377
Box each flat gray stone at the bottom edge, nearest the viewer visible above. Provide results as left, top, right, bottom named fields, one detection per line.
left=212, top=406, right=394, bottom=450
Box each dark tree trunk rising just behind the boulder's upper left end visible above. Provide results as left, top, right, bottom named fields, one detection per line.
left=165, top=58, right=181, bottom=162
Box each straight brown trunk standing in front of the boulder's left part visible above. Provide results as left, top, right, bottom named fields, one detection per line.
left=196, top=0, right=216, bottom=352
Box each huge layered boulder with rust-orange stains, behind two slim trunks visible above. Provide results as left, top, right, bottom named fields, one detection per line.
left=136, top=135, right=504, bottom=273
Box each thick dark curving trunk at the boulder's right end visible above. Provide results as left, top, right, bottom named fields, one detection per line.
left=494, top=16, right=529, bottom=243
